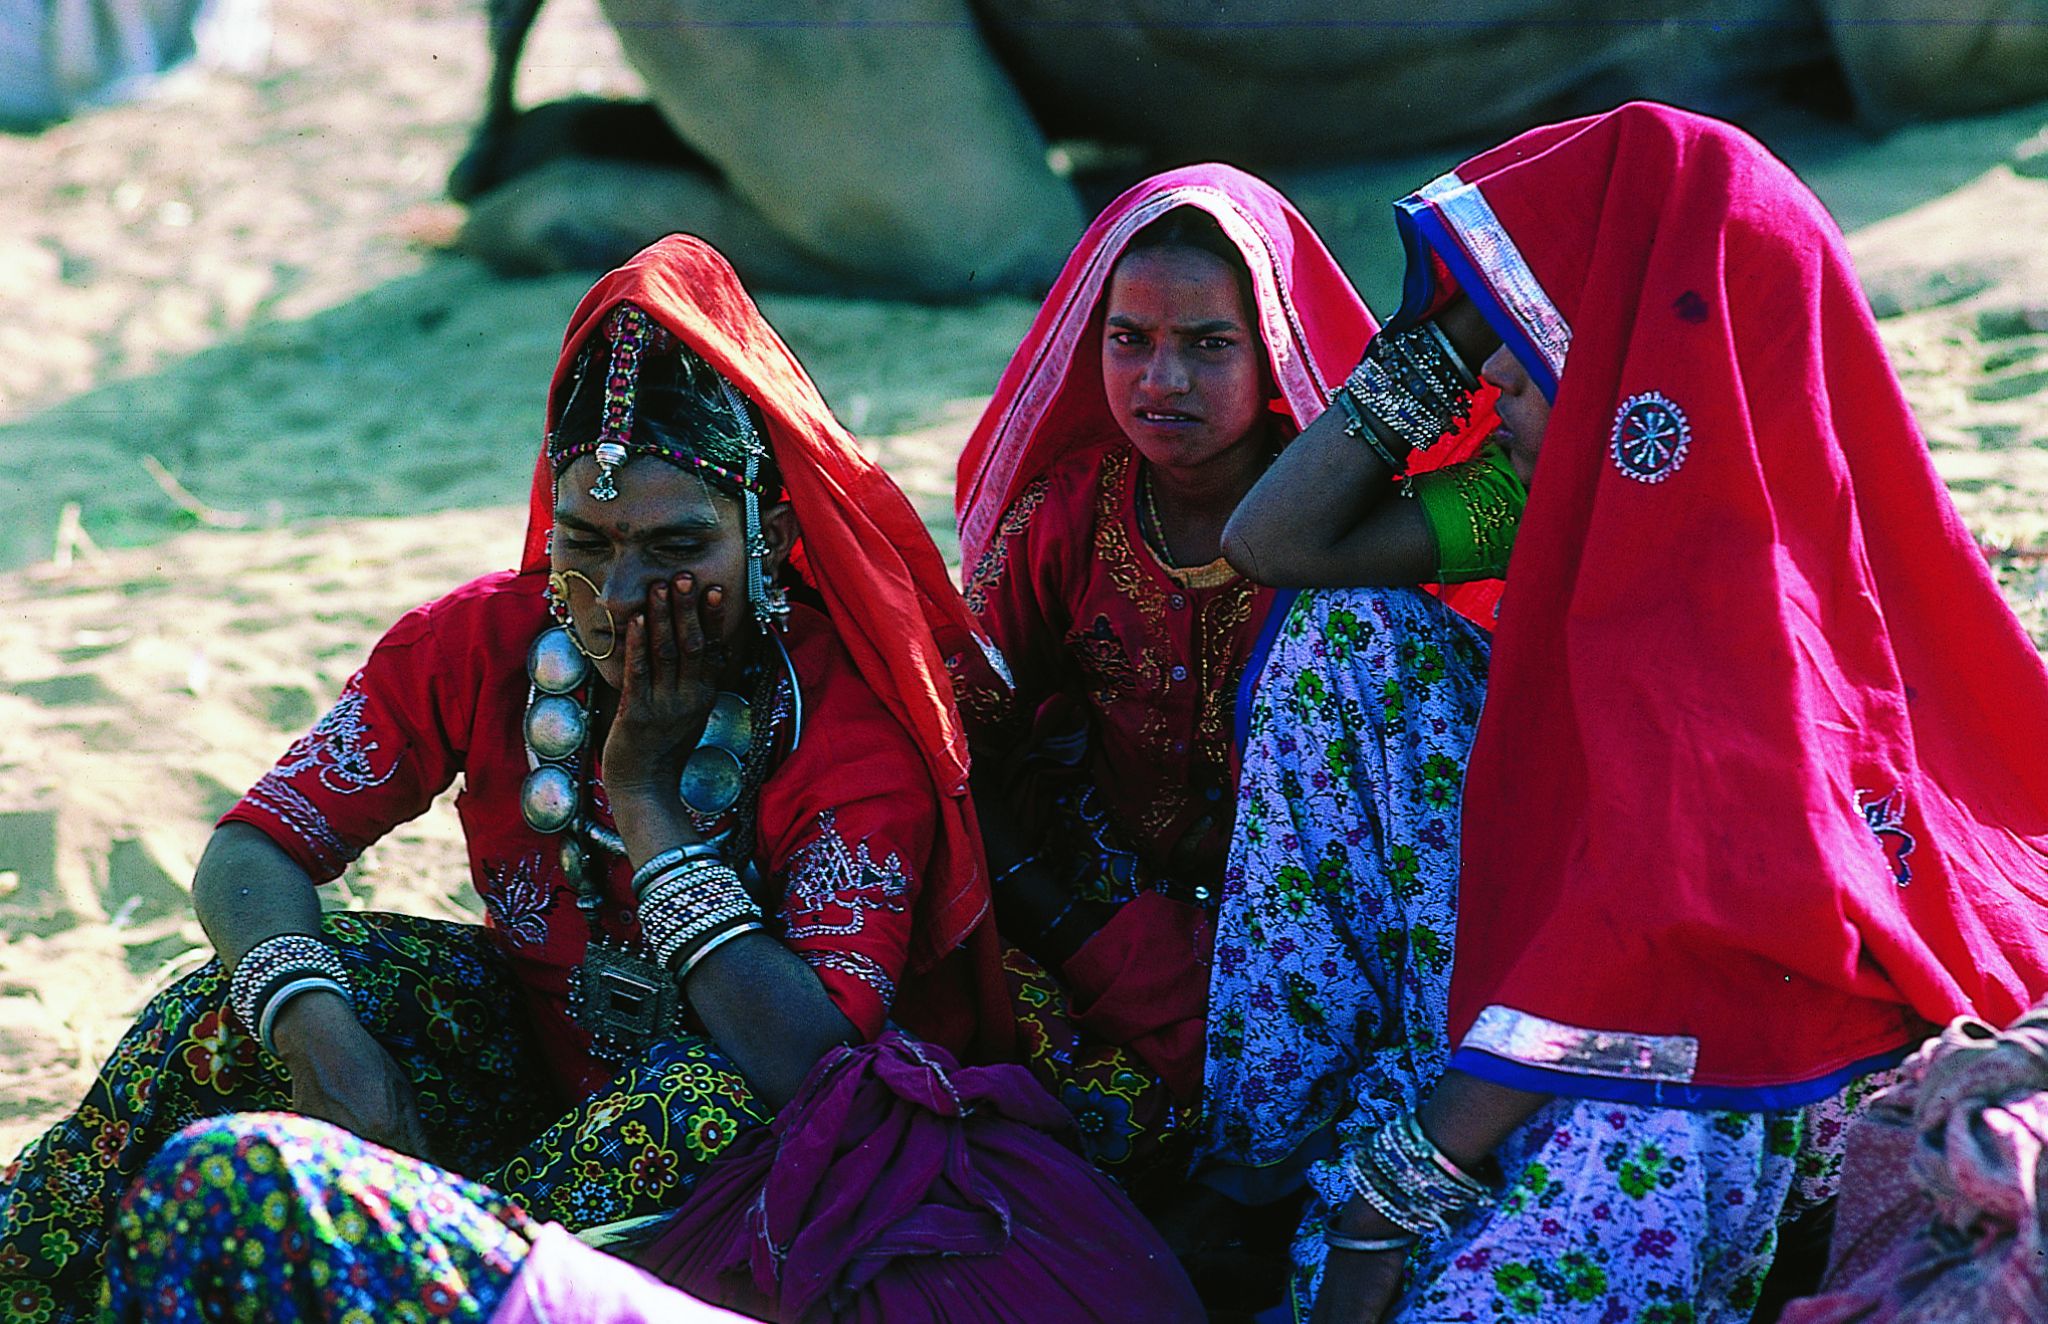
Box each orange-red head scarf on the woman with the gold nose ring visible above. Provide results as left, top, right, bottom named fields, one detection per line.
left=520, top=234, right=989, bottom=983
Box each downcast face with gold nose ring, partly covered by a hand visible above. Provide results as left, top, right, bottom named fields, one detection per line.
left=551, top=455, right=797, bottom=689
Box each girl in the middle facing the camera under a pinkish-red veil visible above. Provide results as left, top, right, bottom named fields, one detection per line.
left=956, top=166, right=1490, bottom=1162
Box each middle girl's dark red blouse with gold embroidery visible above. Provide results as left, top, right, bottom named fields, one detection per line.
left=958, top=435, right=1272, bottom=896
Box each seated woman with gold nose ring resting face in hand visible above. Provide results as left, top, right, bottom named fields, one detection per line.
left=0, top=236, right=1012, bottom=1318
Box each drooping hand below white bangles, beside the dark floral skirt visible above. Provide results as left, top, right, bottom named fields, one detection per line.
left=272, top=992, right=434, bottom=1160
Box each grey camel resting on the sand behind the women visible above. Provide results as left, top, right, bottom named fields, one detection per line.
left=451, top=0, right=2048, bottom=299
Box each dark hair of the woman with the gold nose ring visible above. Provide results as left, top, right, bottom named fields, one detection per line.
left=547, top=332, right=782, bottom=496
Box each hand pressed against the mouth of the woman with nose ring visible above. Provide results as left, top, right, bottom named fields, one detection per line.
left=604, top=574, right=727, bottom=808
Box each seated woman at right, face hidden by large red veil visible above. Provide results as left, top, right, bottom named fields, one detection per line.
left=1206, top=105, right=2048, bottom=1322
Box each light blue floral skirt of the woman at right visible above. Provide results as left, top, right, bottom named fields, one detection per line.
left=1204, top=588, right=1868, bottom=1324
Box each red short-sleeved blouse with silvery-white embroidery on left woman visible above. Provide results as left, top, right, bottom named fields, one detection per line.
left=221, top=572, right=973, bottom=1099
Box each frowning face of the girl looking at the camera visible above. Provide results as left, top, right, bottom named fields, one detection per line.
left=1102, top=248, right=1266, bottom=469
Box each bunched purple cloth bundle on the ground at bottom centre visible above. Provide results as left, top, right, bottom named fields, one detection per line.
left=635, top=1033, right=1204, bottom=1324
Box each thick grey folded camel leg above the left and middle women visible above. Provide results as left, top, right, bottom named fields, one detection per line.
left=602, top=0, right=1083, bottom=297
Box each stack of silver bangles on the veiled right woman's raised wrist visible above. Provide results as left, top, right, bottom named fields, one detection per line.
left=1329, top=322, right=1479, bottom=475
